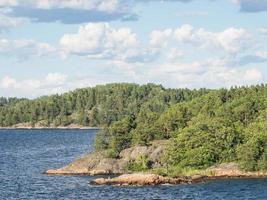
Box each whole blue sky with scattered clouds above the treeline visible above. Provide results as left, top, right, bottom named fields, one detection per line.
left=0, top=0, right=267, bottom=98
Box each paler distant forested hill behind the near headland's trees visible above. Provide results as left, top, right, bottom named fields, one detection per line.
left=0, top=83, right=208, bottom=127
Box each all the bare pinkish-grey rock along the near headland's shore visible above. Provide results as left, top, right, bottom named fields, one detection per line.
left=45, top=141, right=267, bottom=185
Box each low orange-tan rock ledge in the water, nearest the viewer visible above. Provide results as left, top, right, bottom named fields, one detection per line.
left=92, top=173, right=204, bottom=186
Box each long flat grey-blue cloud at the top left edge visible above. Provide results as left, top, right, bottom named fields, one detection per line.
left=0, top=0, right=135, bottom=24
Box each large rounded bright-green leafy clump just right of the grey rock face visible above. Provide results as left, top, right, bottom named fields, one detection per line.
left=168, top=116, right=241, bottom=169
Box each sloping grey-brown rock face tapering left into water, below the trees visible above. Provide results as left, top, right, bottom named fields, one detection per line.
left=45, top=141, right=166, bottom=175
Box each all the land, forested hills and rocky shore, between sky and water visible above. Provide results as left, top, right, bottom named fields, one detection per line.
left=0, top=83, right=267, bottom=185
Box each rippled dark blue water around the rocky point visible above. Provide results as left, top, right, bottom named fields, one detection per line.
left=0, top=130, right=267, bottom=200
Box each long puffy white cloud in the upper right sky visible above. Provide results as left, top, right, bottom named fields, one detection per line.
left=150, top=24, right=249, bottom=54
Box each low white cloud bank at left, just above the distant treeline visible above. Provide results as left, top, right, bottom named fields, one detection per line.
left=0, top=72, right=117, bottom=98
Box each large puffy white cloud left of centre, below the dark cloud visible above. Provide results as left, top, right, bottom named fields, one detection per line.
left=60, top=23, right=155, bottom=62
